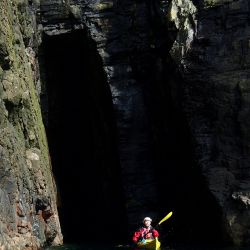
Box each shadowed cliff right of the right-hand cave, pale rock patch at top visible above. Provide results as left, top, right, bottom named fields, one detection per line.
left=168, top=0, right=250, bottom=244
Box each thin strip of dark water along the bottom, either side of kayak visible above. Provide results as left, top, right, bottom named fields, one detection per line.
left=45, top=245, right=250, bottom=250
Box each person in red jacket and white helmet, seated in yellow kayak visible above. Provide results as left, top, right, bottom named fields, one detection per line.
left=132, top=217, right=159, bottom=243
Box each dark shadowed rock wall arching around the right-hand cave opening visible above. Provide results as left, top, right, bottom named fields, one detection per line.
left=38, top=0, right=250, bottom=244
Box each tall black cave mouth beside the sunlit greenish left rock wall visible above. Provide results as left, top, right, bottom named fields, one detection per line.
left=40, top=30, right=127, bottom=243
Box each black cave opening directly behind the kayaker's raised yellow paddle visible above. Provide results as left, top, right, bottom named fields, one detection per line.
left=134, top=54, right=230, bottom=244
